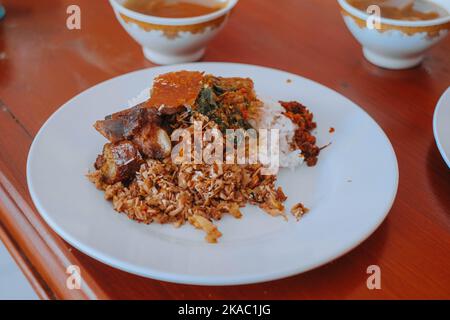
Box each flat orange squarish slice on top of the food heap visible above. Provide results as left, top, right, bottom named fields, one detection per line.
left=146, top=71, right=203, bottom=115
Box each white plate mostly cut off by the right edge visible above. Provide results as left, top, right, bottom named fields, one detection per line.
left=433, top=88, right=450, bottom=168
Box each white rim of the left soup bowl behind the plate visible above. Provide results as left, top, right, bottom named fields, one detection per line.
left=109, top=0, right=239, bottom=26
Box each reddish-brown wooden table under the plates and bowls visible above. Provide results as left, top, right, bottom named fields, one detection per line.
left=0, top=0, right=450, bottom=299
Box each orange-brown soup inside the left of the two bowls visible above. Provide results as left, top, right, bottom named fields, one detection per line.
left=123, top=0, right=226, bottom=18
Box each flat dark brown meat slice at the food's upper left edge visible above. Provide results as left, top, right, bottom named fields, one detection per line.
left=94, top=104, right=160, bottom=142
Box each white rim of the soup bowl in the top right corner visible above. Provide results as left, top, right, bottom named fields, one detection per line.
left=338, top=0, right=450, bottom=28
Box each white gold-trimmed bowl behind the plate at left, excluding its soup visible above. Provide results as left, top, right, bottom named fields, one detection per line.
left=109, top=0, right=238, bottom=64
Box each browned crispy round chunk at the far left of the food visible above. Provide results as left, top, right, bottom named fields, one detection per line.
left=94, top=140, right=143, bottom=185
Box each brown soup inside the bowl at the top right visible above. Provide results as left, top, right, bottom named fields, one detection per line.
left=347, top=0, right=449, bottom=21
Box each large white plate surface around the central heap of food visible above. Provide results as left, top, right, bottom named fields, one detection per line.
left=27, top=63, right=398, bottom=285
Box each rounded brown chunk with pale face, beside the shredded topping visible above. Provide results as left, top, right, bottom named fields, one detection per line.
left=133, top=123, right=172, bottom=159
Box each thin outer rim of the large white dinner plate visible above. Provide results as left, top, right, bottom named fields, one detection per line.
left=26, top=62, right=399, bottom=286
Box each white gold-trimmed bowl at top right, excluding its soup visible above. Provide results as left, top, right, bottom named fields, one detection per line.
left=338, top=0, right=450, bottom=69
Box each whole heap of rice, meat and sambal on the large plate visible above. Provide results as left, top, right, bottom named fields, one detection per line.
left=88, top=71, right=320, bottom=243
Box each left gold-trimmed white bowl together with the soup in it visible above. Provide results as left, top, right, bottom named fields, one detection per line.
left=110, top=0, right=238, bottom=65
